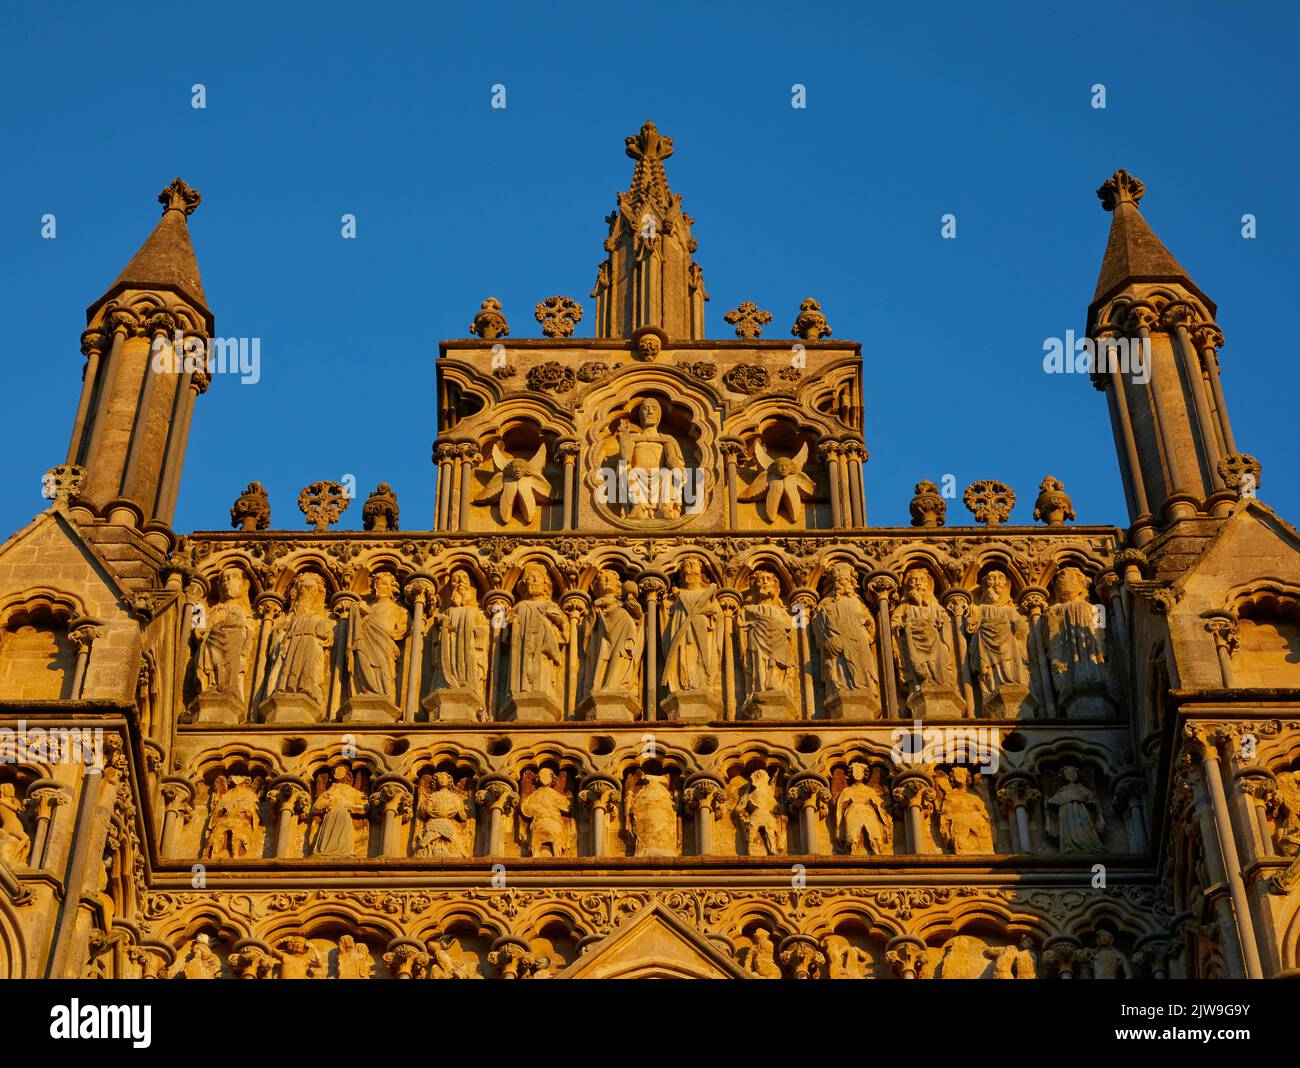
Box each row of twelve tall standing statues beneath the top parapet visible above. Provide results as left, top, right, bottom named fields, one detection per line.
left=194, top=557, right=1118, bottom=722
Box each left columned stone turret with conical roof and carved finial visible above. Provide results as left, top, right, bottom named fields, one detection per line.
left=68, top=178, right=213, bottom=547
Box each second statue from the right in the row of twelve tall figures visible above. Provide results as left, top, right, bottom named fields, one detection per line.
left=962, top=569, right=1030, bottom=720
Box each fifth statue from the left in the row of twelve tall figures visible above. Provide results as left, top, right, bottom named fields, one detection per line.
left=501, top=564, right=568, bottom=721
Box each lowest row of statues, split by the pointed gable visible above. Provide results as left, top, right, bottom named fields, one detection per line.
left=157, top=928, right=1141, bottom=980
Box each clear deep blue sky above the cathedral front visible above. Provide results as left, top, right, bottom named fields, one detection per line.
left=0, top=1, right=1300, bottom=533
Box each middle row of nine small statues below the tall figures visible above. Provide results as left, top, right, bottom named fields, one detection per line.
left=195, top=761, right=1106, bottom=859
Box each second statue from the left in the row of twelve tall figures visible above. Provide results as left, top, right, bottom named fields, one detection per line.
left=261, top=572, right=334, bottom=724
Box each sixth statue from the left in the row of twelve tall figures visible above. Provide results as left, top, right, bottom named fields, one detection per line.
left=577, top=569, right=645, bottom=721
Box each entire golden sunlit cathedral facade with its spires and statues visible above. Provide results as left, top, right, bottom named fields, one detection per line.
left=0, top=122, right=1300, bottom=980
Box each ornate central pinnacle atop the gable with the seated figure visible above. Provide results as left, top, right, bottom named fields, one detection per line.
left=592, top=122, right=709, bottom=338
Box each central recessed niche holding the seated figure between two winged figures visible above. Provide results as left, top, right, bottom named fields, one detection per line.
left=595, top=396, right=705, bottom=526
